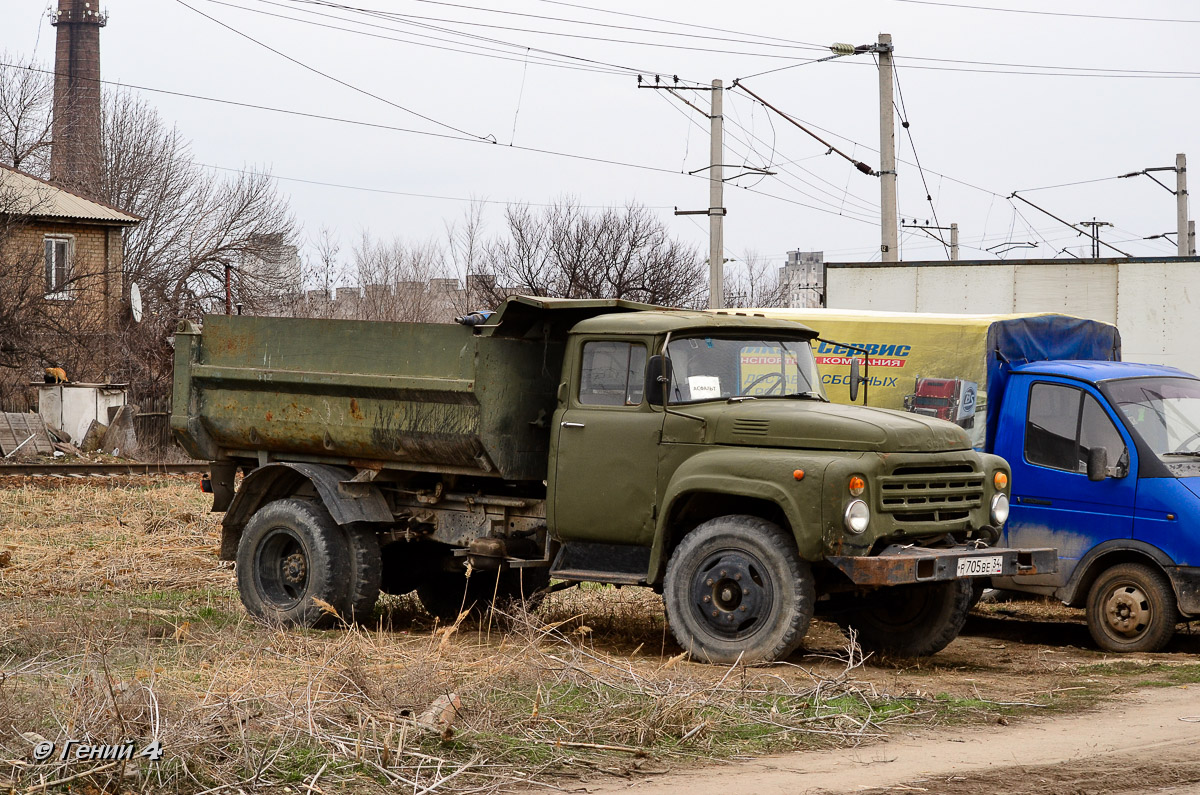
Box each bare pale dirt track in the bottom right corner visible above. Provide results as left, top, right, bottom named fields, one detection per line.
left=561, top=686, right=1200, bottom=795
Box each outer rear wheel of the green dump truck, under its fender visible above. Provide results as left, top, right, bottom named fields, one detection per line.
left=236, top=500, right=352, bottom=627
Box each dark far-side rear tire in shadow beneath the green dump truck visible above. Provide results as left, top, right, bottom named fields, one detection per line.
left=416, top=568, right=550, bottom=623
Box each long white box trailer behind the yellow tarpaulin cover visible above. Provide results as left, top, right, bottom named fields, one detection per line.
left=826, top=257, right=1200, bottom=373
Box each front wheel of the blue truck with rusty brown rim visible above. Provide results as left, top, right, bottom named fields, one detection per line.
left=1087, top=563, right=1180, bottom=652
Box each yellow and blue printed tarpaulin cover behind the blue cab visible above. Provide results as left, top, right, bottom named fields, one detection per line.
left=731, top=309, right=1121, bottom=449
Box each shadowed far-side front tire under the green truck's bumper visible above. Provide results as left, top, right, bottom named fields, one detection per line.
left=836, top=580, right=974, bottom=657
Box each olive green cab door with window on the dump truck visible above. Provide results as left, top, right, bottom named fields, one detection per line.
left=547, top=337, right=662, bottom=545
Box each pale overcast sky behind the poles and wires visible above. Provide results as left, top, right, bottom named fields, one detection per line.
left=0, top=0, right=1200, bottom=278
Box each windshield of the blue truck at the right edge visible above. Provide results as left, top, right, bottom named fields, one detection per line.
left=1106, top=377, right=1200, bottom=456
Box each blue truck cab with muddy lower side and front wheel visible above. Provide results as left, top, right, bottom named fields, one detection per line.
left=988, top=357, right=1200, bottom=652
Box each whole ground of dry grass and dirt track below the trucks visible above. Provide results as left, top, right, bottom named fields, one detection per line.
left=0, top=478, right=1200, bottom=795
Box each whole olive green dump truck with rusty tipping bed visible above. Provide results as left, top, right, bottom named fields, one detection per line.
left=172, top=297, right=1056, bottom=663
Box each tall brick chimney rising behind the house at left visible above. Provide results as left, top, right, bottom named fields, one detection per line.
left=50, top=0, right=108, bottom=198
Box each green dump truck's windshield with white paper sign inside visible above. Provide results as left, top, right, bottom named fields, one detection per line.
left=667, top=336, right=826, bottom=404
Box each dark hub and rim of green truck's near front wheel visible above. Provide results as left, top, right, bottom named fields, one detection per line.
left=691, top=551, right=772, bottom=638
